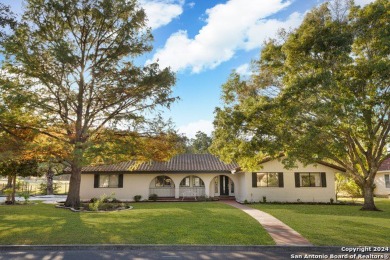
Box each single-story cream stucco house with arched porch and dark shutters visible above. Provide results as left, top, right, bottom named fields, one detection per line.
left=80, top=154, right=343, bottom=202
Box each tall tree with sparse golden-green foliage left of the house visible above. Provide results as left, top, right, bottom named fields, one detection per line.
left=2, top=0, right=175, bottom=207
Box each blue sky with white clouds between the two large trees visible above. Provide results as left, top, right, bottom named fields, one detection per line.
left=0, top=0, right=373, bottom=138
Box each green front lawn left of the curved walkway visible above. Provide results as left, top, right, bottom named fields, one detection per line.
left=0, top=202, right=274, bottom=245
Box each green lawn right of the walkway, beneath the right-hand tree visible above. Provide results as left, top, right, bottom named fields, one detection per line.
left=252, top=199, right=390, bottom=246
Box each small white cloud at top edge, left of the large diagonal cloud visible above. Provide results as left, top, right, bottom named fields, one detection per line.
left=141, top=0, right=184, bottom=29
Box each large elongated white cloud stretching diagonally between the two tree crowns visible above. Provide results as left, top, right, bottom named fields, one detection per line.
left=147, top=0, right=302, bottom=73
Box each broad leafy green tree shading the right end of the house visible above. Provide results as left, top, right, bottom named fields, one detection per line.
left=212, top=0, right=390, bottom=210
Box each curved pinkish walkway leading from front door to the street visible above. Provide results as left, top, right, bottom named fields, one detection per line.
left=221, top=200, right=312, bottom=246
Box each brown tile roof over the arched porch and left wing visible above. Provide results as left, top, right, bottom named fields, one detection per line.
left=82, top=154, right=238, bottom=173
